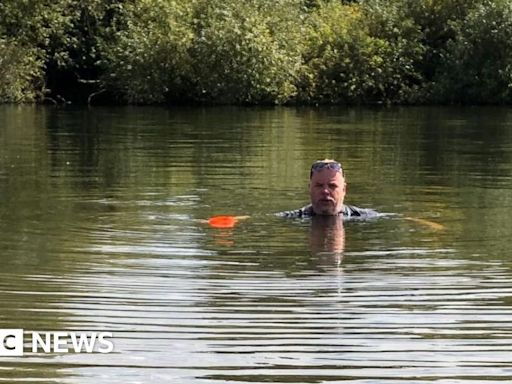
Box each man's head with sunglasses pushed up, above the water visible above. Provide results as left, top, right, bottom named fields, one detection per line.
left=309, top=159, right=347, bottom=215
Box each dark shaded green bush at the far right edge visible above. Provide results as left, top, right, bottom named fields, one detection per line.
left=435, top=0, right=512, bottom=104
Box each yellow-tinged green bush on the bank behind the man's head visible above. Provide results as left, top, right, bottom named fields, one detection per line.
left=305, top=1, right=424, bottom=103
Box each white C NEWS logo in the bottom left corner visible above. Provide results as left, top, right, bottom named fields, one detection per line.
left=0, top=329, right=114, bottom=356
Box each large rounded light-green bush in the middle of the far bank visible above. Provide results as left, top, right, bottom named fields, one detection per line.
left=191, top=0, right=305, bottom=103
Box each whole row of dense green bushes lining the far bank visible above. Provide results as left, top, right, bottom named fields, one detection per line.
left=0, top=0, right=512, bottom=104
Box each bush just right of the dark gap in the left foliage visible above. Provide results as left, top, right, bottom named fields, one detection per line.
left=100, top=0, right=196, bottom=103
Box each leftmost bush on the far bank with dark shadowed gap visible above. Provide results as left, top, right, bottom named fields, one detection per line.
left=0, top=0, right=122, bottom=102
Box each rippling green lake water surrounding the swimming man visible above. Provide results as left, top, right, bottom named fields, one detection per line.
left=0, top=106, right=512, bottom=384
